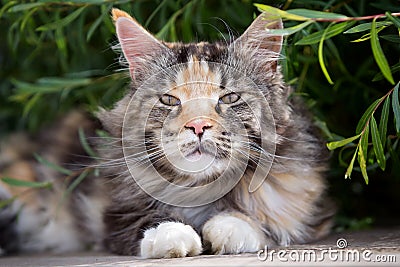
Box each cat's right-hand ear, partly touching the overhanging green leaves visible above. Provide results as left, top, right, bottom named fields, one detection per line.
left=232, top=13, right=283, bottom=71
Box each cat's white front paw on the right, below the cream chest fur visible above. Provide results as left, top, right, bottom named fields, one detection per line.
left=203, top=214, right=266, bottom=254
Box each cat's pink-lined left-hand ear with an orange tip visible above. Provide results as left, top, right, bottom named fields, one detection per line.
left=112, top=8, right=166, bottom=79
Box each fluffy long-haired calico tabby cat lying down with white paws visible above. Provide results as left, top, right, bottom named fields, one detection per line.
left=0, top=9, right=334, bottom=258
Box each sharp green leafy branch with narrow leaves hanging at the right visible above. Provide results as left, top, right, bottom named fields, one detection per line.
left=256, top=4, right=400, bottom=184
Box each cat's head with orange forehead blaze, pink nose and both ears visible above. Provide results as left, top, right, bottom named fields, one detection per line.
left=101, top=10, right=289, bottom=189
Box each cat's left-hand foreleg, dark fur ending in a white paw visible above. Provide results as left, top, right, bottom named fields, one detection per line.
left=104, top=208, right=202, bottom=258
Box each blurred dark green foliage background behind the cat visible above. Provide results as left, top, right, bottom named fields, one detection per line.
left=0, top=0, right=400, bottom=228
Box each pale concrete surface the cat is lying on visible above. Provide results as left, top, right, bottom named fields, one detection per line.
left=0, top=228, right=400, bottom=267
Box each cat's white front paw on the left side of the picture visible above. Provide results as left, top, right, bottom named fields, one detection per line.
left=140, top=222, right=202, bottom=258
